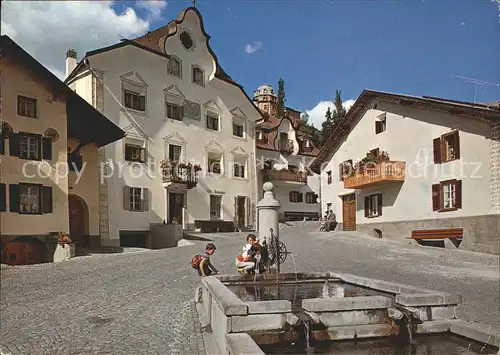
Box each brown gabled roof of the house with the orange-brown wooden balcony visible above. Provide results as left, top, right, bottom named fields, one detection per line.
left=310, top=89, right=500, bottom=173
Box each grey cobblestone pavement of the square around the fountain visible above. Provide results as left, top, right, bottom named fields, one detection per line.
left=0, top=223, right=500, bottom=355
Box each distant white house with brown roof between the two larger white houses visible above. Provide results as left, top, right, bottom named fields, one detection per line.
left=253, top=84, right=321, bottom=221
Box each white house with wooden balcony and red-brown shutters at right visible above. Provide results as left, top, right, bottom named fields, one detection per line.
left=311, top=90, right=500, bottom=254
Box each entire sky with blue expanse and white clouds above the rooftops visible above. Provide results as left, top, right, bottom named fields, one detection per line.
left=1, top=0, right=500, bottom=128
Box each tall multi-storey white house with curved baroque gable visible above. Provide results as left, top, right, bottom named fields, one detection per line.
left=66, top=7, right=262, bottom=245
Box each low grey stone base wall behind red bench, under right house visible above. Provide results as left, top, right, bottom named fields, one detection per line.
left=352, top=214, right=500, bottom=255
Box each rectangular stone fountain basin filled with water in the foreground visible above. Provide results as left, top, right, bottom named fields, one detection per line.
left=195, top=272, right=499, bottom=355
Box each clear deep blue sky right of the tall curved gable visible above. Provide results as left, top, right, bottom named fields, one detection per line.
left=125, top=0, right=500, bottom=115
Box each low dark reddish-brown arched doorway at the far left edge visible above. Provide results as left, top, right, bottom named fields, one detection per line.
left=2, top=237, right=47, bottom=265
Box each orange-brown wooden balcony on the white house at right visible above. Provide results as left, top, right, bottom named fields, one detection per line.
left=344, top=161, right=406, bottom=189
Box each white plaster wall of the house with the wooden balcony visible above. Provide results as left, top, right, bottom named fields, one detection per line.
left=321, top=103, right=491, bottom=224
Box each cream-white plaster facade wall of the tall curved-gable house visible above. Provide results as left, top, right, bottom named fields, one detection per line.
left=72, top=12, right=260, bottom=239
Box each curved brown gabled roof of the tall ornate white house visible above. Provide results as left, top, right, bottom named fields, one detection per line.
left=64, top=7, right=262, bottom=117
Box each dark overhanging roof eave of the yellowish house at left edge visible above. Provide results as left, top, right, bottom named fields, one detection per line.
left=0, top=35, right=125, bottom=147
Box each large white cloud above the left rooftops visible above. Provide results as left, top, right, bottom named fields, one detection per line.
left=1, top=1, right=166, bottom=79
